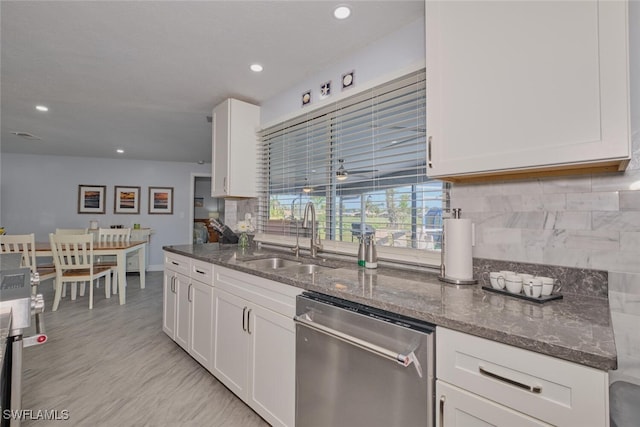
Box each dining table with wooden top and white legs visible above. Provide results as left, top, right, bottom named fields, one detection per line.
left=35, top=241, right=147, bottom=305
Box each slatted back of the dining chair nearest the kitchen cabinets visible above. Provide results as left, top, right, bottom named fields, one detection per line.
left=49, top=233, right=93, bottom=271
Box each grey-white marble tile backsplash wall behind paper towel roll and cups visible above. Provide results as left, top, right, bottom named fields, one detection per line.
left=451, top=1, right=640, bottom=384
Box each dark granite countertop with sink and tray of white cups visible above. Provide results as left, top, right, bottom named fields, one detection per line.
left=164, top=244, right=617, bottom=370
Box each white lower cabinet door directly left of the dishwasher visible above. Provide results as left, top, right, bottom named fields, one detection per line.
left=247, top=305, right=296, bottom=426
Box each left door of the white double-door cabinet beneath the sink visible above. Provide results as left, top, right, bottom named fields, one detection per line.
left=213, top=288, right=249, bottom=401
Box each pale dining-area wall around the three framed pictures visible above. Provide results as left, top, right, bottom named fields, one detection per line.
left=0, top=153, right=211, bottom=270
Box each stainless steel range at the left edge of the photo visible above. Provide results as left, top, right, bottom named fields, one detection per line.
left=0, top=254, right=47, bottom=427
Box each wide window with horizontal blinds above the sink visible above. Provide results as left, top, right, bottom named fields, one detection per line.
left=259, top=70, right=443, bottom=260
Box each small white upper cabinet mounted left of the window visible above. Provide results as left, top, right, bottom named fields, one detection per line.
left=211, top=99, right=260, bottom=197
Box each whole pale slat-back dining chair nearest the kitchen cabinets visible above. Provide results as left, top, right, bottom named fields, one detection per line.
left=49, top=233, right=111, bottom=311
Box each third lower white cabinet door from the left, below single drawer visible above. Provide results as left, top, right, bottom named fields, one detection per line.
left=189, top=279, right=213, bottom=371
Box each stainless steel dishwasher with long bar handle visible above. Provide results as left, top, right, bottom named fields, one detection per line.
left=294, top=292, right=435, bottom=427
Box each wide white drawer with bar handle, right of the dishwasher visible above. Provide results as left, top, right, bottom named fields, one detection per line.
left=436, top=327, right=609, bottom=426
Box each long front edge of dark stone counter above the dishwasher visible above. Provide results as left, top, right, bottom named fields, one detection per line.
left=163, top=245, right=618, bottom=371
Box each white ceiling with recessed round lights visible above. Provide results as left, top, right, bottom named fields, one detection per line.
left=0, top=0, right=424, bottom=162
